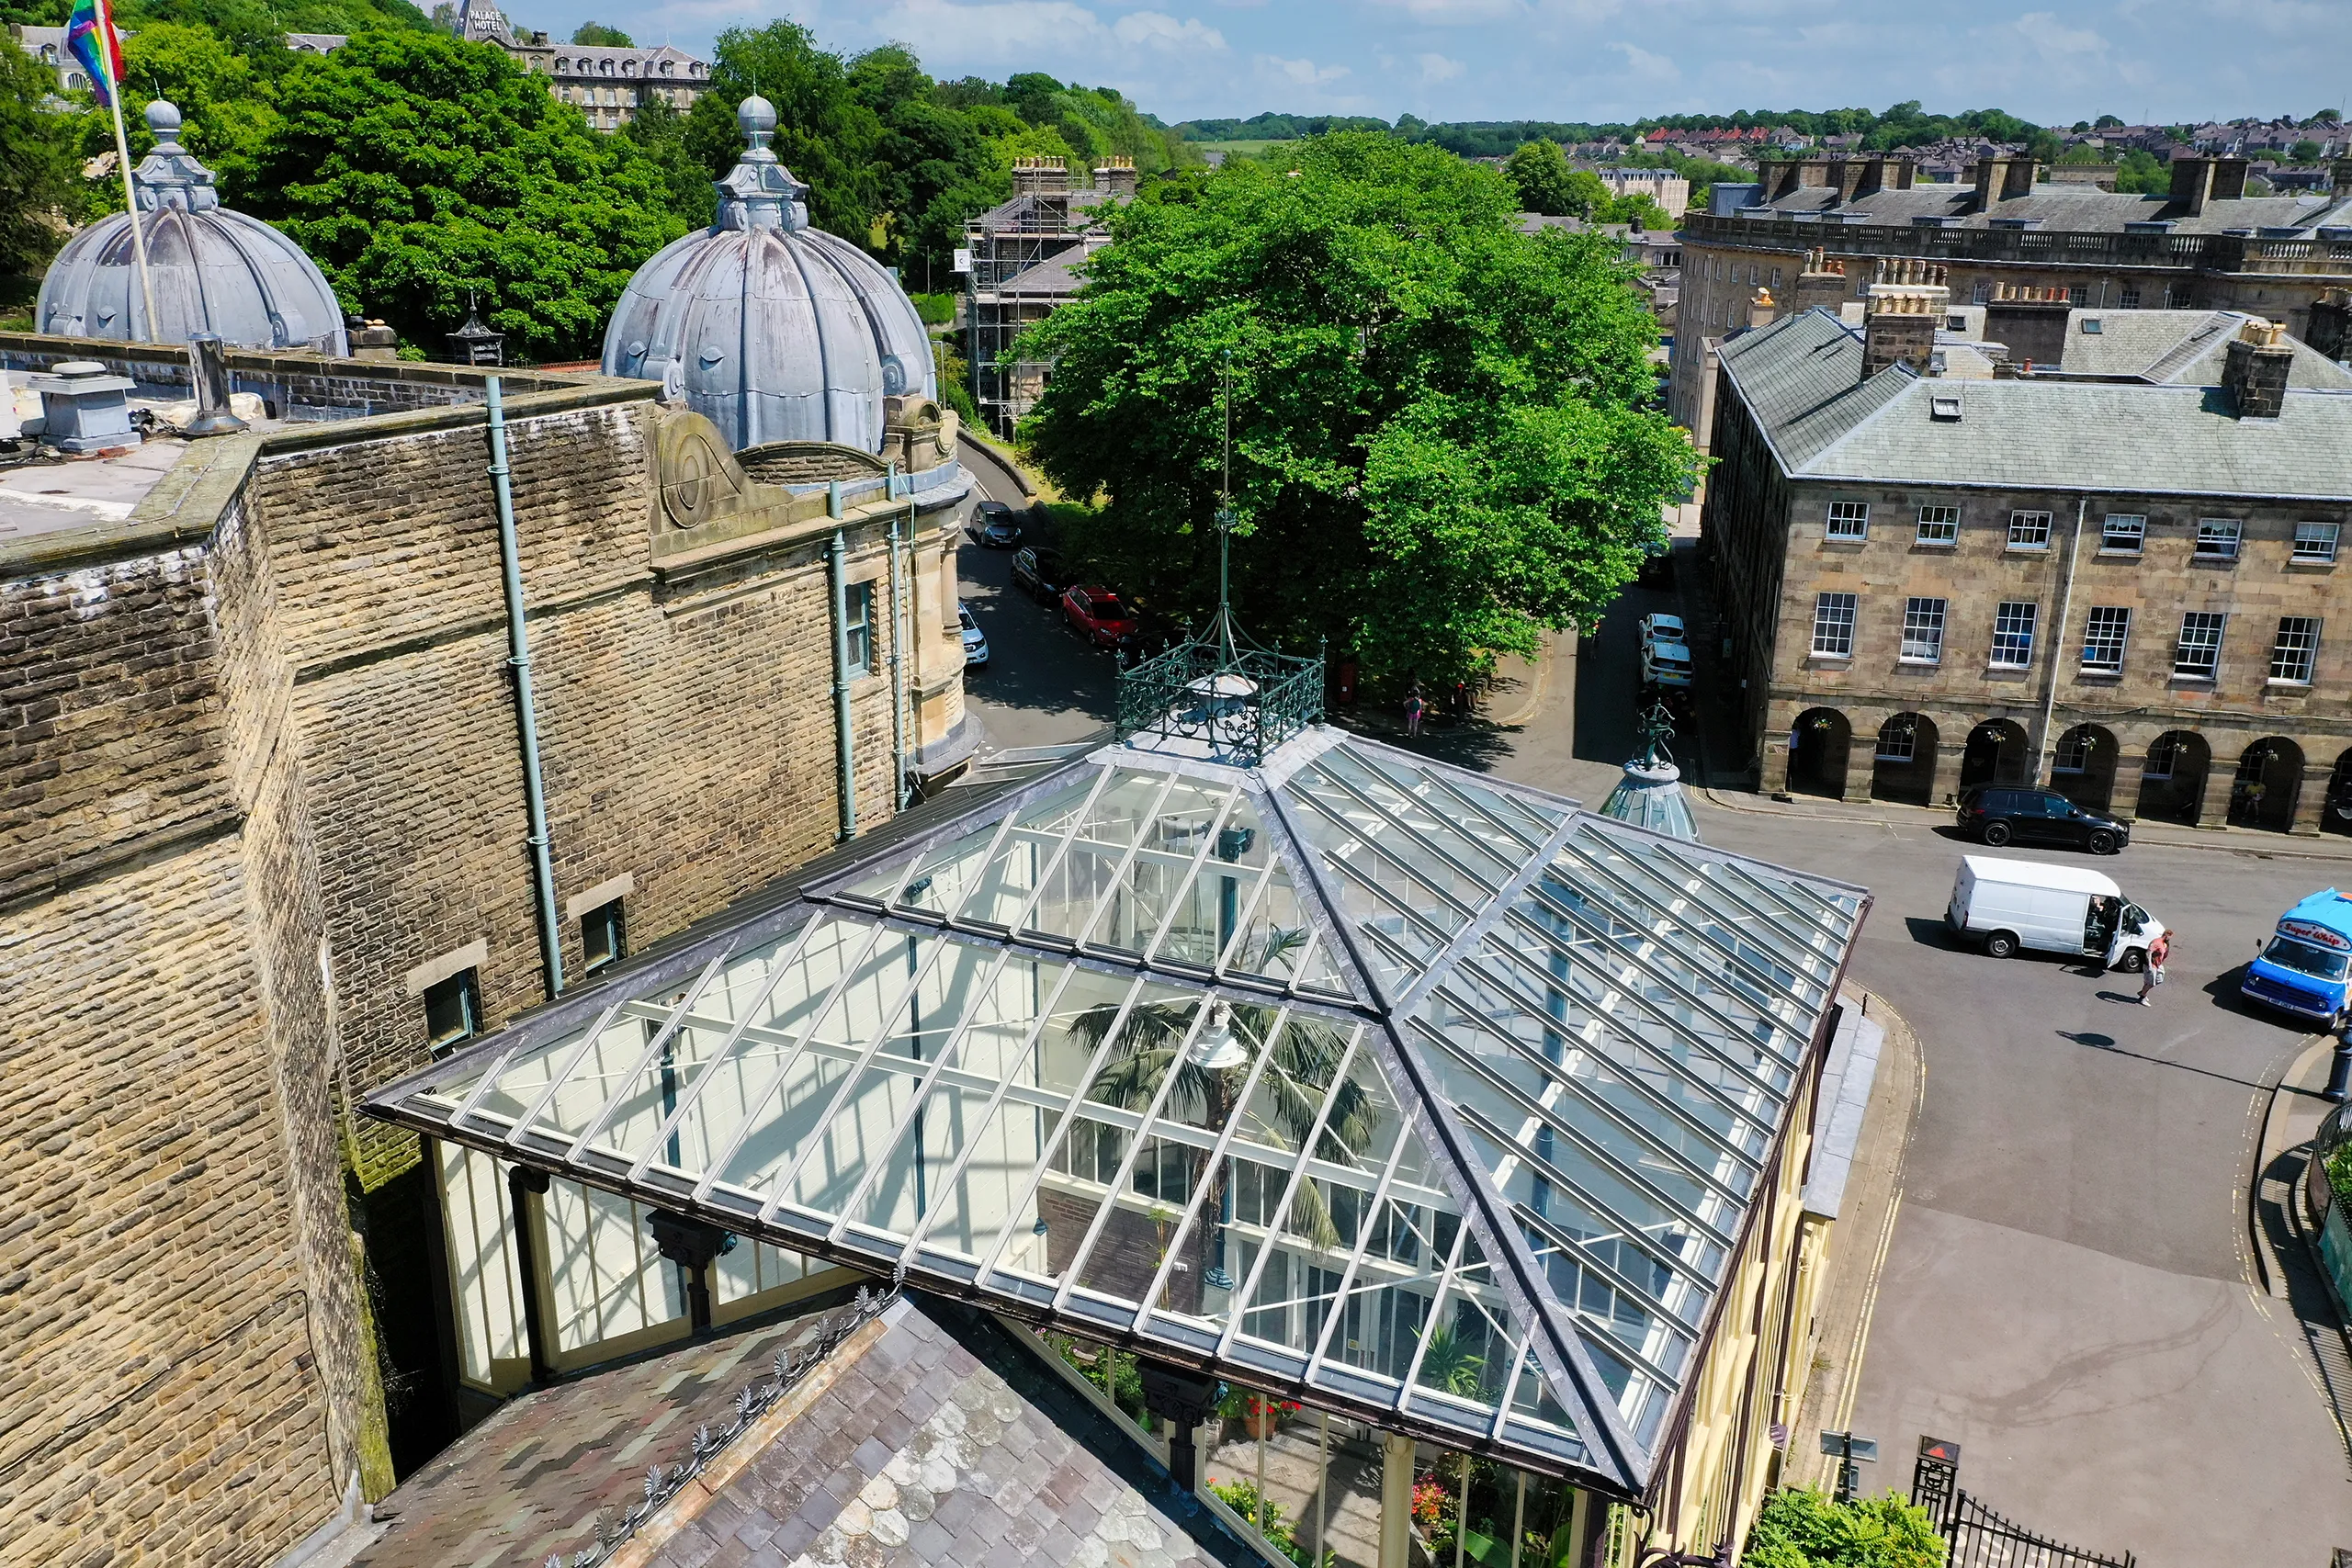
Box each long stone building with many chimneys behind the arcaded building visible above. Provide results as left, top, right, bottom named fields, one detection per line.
left=1668, top=155, right=2352, bottom=451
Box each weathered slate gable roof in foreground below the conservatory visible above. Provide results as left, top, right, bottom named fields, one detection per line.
left=353, top=1295, right=1263, bottom=1568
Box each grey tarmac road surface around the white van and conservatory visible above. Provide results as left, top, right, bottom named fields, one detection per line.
left=965, top=460, right=2352, bottom=1568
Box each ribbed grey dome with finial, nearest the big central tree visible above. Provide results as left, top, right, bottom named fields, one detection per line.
left=605, top=96, right=938, bottom=451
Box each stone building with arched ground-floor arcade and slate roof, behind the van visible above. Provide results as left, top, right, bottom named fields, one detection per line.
left=1702, top=293, right=2352, bottom=832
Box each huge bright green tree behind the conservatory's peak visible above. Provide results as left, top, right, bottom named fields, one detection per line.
left=1018, top=131, right=1693, bottom=680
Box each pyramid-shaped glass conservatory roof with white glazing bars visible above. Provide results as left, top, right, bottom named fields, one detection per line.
left=369, top=727, right=1868, bottom=1495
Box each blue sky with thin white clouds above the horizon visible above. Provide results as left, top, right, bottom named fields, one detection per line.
left=555, top=0, right=2352, bottom=125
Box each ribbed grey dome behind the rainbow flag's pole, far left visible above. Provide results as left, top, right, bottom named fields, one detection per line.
left=33, top=98, right=350, bottom=355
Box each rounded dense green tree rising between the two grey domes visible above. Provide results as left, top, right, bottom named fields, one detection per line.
left=245, top=33, right=684, bottom=360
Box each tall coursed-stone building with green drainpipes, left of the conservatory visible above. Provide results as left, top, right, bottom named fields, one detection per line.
left=0, top=333, right=971, bottom=1563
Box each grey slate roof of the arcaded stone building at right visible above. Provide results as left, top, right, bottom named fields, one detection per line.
left=1722, top=308, right=2352, bottom=501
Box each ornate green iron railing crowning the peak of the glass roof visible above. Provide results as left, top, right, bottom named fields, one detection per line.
left=1120, top=639, right=1324, bottom=769
